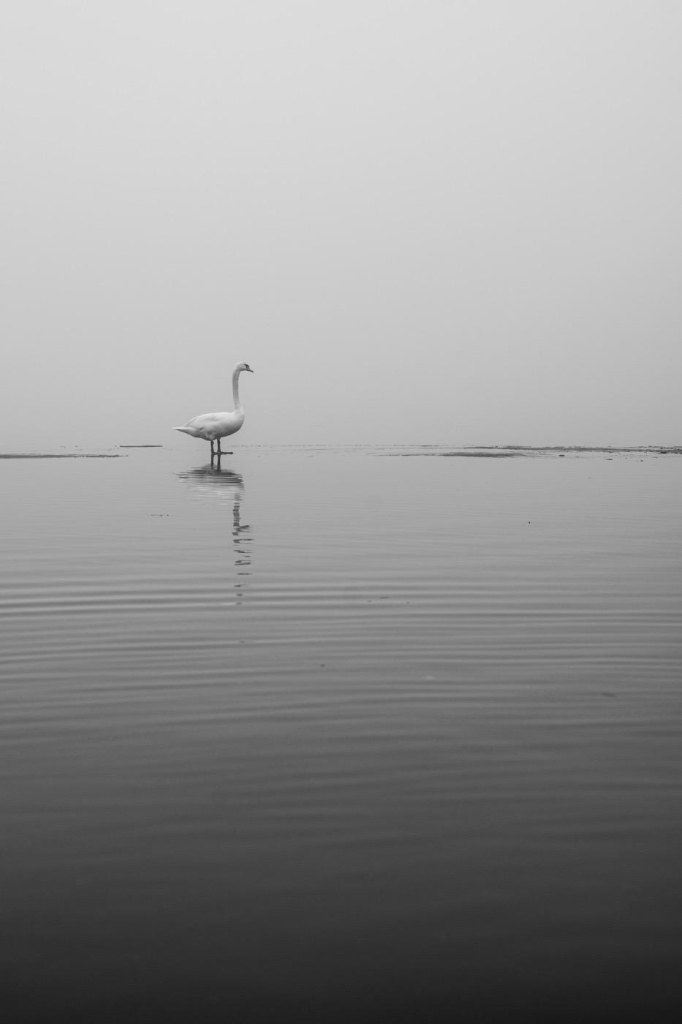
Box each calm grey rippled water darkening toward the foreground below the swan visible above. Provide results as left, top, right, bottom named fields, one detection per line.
left=0, top=443, right=682, bottom=1024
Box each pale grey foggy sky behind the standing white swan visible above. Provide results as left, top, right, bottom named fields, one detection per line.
left=0, top=0, right=682, bottom=452
